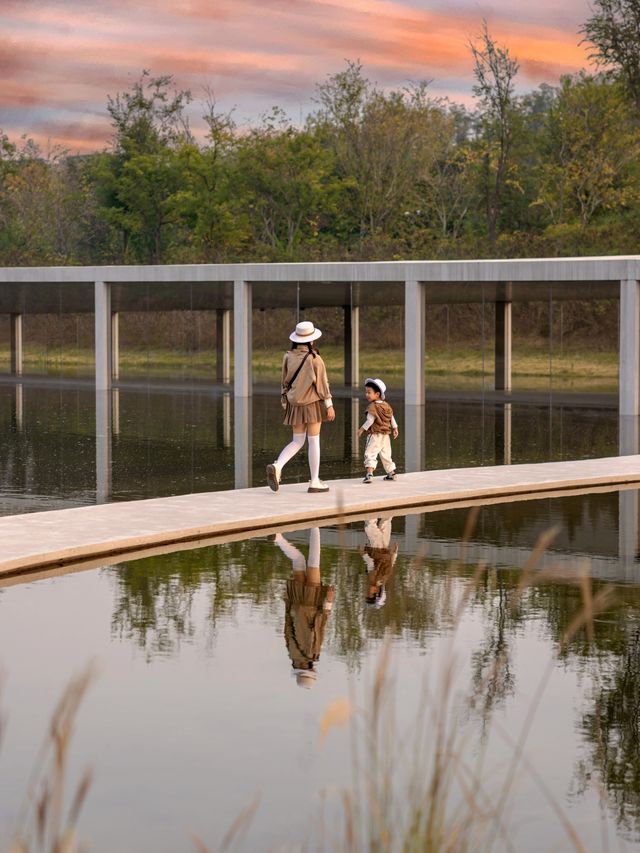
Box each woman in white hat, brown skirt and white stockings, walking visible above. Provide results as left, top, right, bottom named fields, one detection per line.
left=267, top=320, right=336, bottom=492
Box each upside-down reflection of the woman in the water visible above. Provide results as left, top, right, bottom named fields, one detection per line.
left=275, top=527, right=334, bottom=688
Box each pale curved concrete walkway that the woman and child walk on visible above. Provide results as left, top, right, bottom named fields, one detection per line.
left=0, top=456, right=640, bottom=576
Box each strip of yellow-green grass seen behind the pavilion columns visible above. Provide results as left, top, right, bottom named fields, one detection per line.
left=0, top=345, right=618, bottom=392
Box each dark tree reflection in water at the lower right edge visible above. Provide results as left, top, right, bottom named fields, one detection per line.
left=579, top=617, right=640, bottom=832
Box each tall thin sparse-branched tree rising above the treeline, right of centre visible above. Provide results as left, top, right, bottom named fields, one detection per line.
left=469, top=21, right=519, bottom=243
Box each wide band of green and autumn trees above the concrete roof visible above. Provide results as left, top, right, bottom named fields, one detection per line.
left=0, top=0, right=640, bottom=342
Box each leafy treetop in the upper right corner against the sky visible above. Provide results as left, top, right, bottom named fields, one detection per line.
left=580, top=0, right=640, bottom=110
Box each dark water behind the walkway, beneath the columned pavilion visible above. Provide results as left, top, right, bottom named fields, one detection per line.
left=0, top=380, right=618, bottom=515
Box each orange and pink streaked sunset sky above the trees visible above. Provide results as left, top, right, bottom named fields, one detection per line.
left=0, top=0, right=589, bottom=152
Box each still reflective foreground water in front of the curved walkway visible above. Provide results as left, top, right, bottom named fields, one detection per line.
left=0, top=496, right=640, bottom=853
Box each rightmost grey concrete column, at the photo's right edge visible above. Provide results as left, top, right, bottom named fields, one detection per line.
left=618, top=279, right=640, bottom=417
